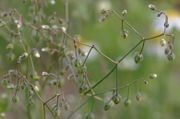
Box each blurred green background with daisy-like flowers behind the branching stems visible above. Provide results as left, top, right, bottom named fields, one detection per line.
left=0, top=0, right=180, bottom=119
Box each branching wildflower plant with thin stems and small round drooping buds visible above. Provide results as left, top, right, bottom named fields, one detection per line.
left=0, top=0, right=175, bottom=119
